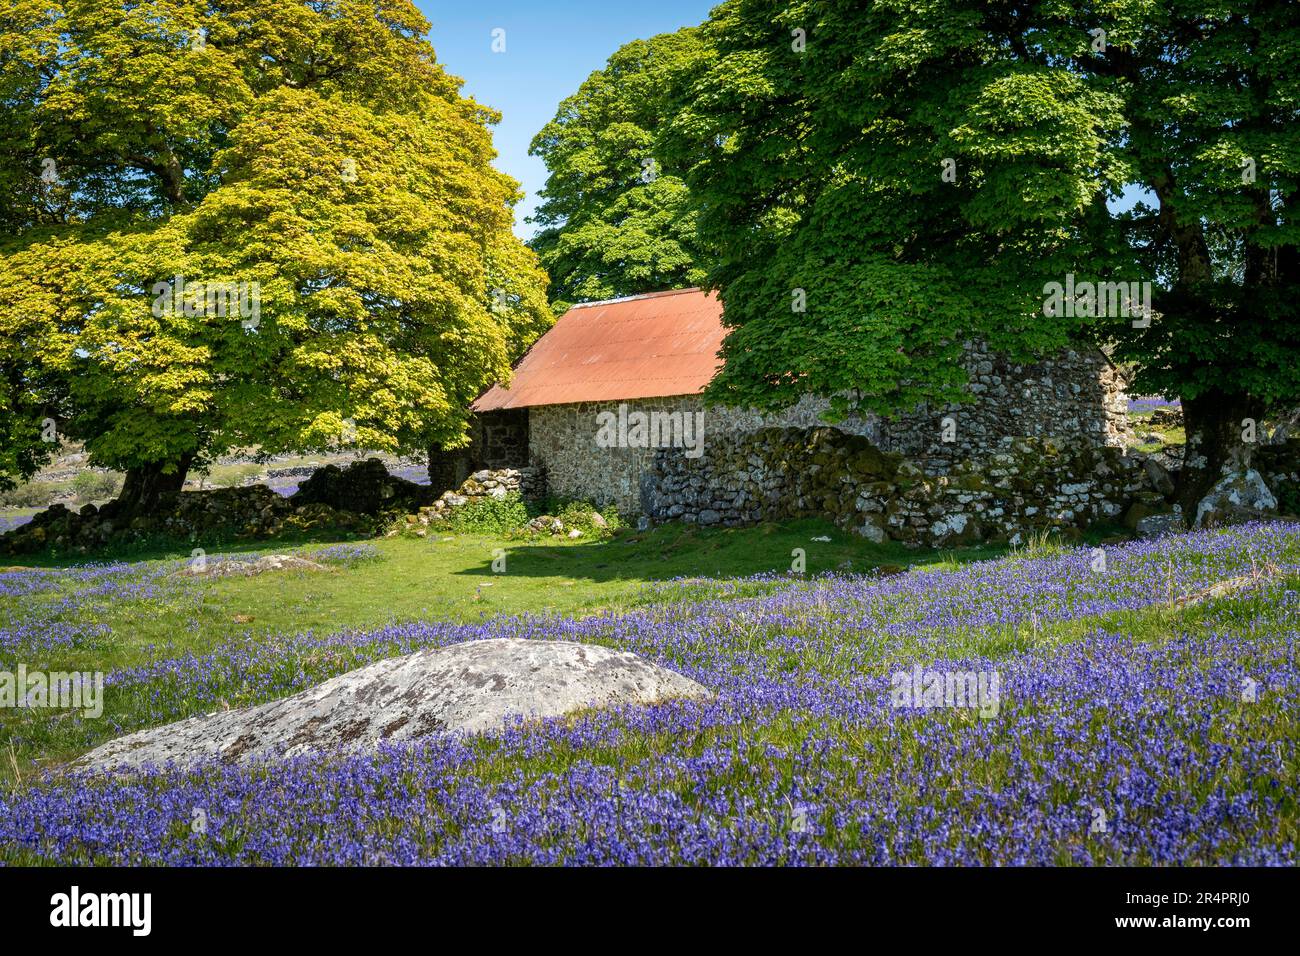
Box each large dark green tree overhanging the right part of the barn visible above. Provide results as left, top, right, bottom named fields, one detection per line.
left=667, top=0, right=1300, bottom=515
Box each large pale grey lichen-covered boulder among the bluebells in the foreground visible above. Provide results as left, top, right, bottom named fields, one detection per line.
left=74, top=639, right=712, bottom=770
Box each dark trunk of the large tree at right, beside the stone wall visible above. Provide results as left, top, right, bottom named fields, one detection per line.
left=1177, top=390, right=1262, bottom=525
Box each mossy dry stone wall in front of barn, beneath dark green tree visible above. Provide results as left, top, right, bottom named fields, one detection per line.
left=645, top=428, right=1169, bottom=545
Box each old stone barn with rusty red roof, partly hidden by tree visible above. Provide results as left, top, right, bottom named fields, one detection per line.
left=429, top=289, right=1126, bottom=515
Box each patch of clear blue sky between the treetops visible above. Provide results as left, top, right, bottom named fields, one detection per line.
left=416, top=0, right=718, bottom=238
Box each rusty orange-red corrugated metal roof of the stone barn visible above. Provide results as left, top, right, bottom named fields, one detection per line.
left=473, top=289, right=727, bottom=411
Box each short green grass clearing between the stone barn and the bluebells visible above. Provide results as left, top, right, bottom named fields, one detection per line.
left=0, top=520, right=1000, bottom=670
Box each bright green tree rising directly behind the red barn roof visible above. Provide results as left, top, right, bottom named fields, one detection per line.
left=529, top=27, right=710, bottom=306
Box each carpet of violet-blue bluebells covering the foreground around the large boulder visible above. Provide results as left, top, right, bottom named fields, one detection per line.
left=0, top=524, right=1300, bottom=865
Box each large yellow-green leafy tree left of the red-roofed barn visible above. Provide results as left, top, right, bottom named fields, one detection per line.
left=0, top=0, right=550, bottom=509
